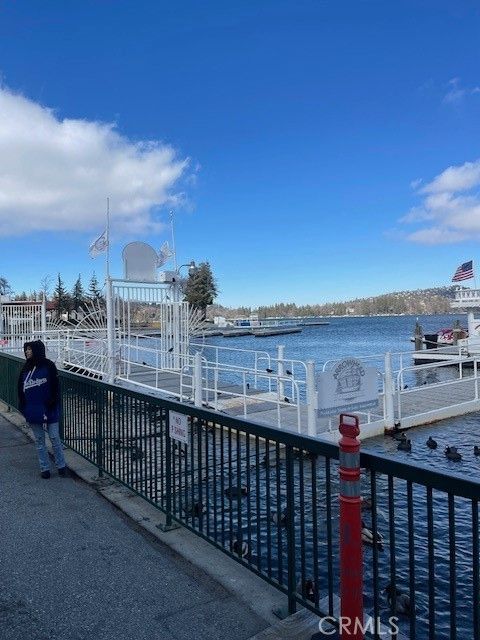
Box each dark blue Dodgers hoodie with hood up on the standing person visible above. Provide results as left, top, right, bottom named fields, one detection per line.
left=18, top=340, right=60, bottom=424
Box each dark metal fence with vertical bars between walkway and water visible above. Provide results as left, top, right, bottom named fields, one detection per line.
left=0, top=354, right=480, bottom=640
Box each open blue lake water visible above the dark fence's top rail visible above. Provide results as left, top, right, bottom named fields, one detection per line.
left=199, top=314, right=480, bottom=477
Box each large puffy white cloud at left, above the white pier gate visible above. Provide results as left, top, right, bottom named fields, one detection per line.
left=0, top=86, right=188, bottom=236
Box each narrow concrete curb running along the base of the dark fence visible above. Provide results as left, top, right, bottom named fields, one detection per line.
left=0, top=402, right=286, bottom=625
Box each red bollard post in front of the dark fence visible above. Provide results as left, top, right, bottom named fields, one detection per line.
left=339, top=413, right=364, bottom=640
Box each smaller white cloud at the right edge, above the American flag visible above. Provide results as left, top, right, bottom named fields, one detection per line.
left=401, top=160, right=480, bottom=244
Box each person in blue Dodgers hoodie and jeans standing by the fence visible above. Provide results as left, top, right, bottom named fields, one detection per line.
left=18, top=340, right=66, bottom=479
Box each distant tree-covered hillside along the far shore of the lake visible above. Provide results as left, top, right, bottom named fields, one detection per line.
left=209, top=286, right=458, bottom=318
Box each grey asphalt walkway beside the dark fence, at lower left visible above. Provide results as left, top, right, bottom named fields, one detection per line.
left=0, top=416, right=267, bottom=640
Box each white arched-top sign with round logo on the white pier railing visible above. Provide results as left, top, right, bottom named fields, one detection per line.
left=317, top=358, right=378, bottom=416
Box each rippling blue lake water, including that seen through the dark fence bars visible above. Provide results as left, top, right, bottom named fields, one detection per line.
left=130, top=314, right=480, bottom=640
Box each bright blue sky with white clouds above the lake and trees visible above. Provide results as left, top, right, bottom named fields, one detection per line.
left=0, top=0, right=480, bottom=307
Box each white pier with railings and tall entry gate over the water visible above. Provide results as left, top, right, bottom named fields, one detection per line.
left=4, top=252, right=480, bottom=440
